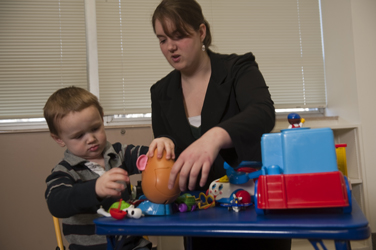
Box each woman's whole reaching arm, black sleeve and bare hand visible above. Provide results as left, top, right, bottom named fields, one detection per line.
left=169, top=55, right=275, bottom=191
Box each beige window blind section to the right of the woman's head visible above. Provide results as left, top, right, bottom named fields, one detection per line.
left=199, top=0, right=326, bottom=108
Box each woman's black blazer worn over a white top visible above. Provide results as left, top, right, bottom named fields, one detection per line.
left=151, top=51, right=275, bottom=188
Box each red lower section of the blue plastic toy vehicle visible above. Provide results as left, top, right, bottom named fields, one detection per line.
left=255, top=171, right=349, bottom=209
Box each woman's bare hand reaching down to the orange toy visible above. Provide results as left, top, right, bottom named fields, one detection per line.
left=168, top=127, right=232, bottom=191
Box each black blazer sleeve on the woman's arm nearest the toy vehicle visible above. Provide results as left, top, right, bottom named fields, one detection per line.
left=217, top=61, right=275, bottom=159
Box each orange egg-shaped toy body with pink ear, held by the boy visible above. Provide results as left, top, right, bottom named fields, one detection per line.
left=137, top=149, right=180, bottom=204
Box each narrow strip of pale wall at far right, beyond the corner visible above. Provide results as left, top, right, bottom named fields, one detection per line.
left=351, top=0, right=376, bottom=232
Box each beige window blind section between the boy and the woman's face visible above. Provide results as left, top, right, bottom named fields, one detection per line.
left=96, top=0, right=172, bottom=114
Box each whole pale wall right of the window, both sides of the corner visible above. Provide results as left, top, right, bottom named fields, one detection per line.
left=321, top=0, right=376, bottom=233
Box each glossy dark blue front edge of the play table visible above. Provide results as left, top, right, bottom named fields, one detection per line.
left=94, top=198, right=371, bottom=241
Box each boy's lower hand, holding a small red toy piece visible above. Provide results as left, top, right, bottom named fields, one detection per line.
left=95, top=168, right=129, bottom=198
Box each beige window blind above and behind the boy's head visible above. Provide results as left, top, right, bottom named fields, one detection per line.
left=0, top=0, right=87, bottom=119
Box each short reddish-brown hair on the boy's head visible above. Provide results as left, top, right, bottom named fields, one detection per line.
left=43, top=86, right=103, bottom=135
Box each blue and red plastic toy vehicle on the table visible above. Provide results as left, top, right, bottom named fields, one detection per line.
left=253, top=128, right=352, bottom=214
